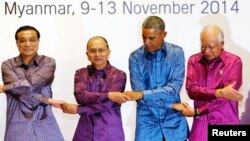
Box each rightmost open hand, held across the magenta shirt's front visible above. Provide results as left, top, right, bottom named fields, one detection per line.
left=215, top=82, right=243, bottom=101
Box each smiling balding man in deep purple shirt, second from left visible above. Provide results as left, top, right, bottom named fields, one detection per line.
left=62, top=36, right=130, bottom=141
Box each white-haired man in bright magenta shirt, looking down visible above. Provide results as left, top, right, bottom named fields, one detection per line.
left=176, top=25, right=243, bottom=141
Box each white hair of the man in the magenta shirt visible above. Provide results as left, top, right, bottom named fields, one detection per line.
left=200, top=25, right=224, bottom=42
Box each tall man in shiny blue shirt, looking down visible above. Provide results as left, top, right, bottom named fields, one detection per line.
left=126, top=16, right=189, bottom=141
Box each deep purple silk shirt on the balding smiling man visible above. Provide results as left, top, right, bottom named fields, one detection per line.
left=73, top=62, right=126, bottom=141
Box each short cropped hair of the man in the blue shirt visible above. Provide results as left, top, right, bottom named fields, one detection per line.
left=142, top=16, right=165, bottom=32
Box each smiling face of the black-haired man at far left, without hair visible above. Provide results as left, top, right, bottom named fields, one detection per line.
left=16, top=30, right=39, bottom=59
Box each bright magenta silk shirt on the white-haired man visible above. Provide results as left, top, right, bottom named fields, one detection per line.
left=186, top=50, right=242, bottom=141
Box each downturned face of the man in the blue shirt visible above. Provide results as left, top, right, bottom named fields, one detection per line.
left=142, top=28, right=167, bottom=52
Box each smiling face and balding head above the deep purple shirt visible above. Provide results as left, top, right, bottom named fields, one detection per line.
left=86, top=37, right=110, bottom=70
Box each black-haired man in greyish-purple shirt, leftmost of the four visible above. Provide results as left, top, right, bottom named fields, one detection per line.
left=0, top=26, right=65, bottom=141
